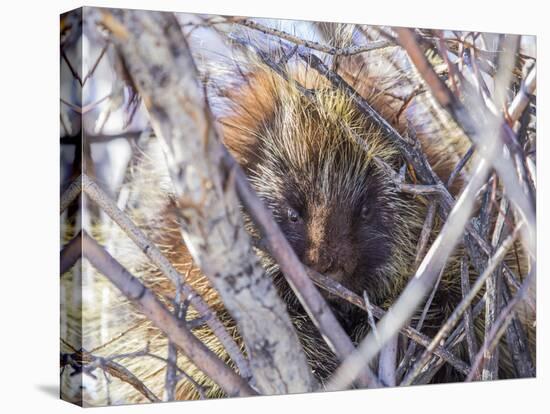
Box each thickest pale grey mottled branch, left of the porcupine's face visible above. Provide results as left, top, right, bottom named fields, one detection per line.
left=101, top=10, right=315, bottom=394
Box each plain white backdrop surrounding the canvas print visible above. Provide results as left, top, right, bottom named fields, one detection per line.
left=0, top=0, right=550, bottom=414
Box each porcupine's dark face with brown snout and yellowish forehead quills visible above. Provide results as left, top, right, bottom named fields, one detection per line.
left=243, top=87, right=410, bottom=306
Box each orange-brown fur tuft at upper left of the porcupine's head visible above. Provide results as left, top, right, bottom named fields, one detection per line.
left=220, top=68, right=280, bottom=170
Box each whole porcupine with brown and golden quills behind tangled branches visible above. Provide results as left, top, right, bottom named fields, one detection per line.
left=63, top=25, right=536, bottom=402
